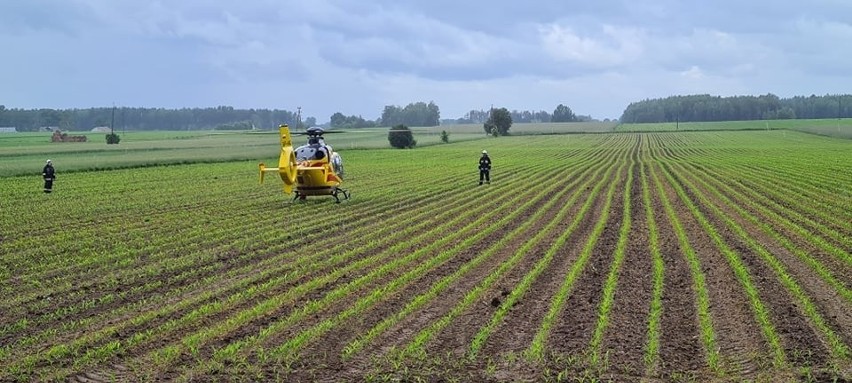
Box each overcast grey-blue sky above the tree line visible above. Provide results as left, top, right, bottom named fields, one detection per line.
left=0, top=0, right=852, bottom=122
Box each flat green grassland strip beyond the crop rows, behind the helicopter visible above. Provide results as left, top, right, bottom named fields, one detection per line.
left=0, top=123, right=614, bottom=177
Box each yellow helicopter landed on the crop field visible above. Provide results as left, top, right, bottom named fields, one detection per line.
left=258, top=124, right=350, bottom=203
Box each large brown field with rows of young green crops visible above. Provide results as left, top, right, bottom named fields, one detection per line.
left=0, top=131, right=852, bottom=382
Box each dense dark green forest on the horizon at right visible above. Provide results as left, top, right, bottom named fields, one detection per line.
left=620, top=93, right=852, bottom=123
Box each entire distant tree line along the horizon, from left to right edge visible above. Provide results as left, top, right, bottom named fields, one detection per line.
left=0, top=94, right=852, bottom=132
